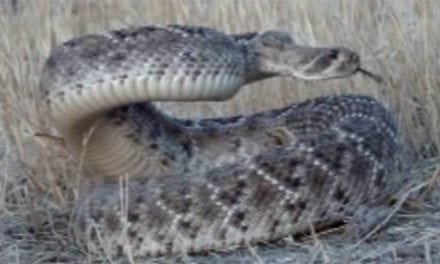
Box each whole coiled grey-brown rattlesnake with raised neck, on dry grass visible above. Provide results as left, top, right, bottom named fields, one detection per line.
left=41, top=25, right=400, bottom=256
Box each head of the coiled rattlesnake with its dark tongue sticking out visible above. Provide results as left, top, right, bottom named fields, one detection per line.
left=254, top=31, right=380, bottom=81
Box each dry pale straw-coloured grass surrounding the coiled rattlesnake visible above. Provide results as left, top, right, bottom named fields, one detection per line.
left=0, top=0, right=440, bottom=263
